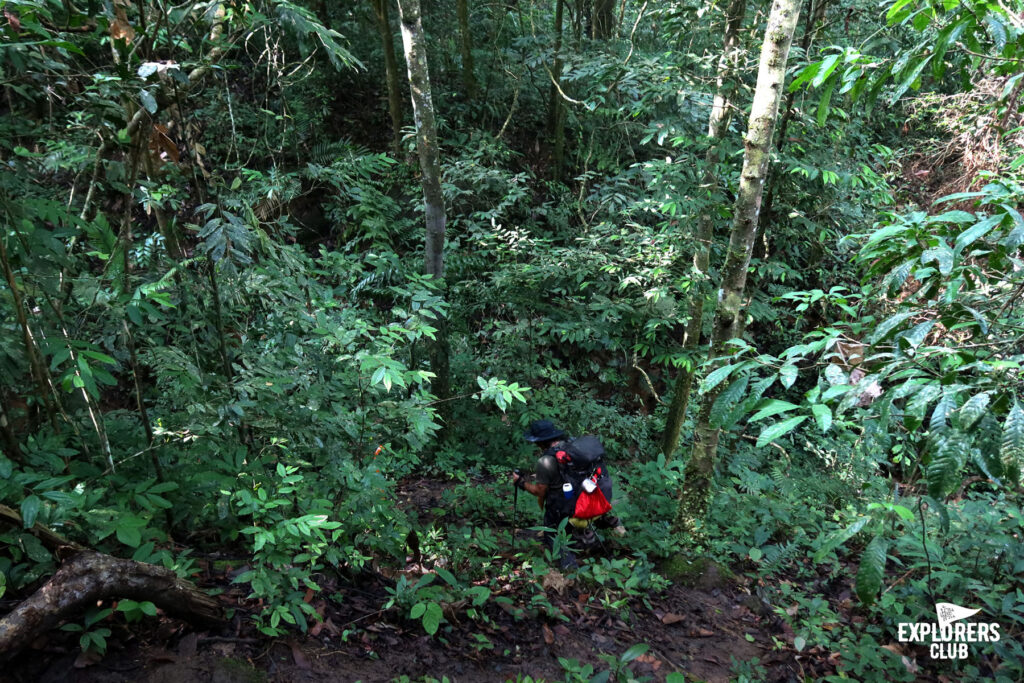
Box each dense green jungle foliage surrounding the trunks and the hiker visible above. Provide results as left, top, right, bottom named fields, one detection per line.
left=0, top=0, right=1024, bottom=680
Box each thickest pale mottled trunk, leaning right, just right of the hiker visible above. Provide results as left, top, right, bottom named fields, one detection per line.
left=676, top=0, right=800, bottom=540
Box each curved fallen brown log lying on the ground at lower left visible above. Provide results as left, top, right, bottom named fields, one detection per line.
left=0, top=551, right=223, bottom=659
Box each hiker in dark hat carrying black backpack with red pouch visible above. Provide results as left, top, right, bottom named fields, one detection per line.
left=512, top=420, right=626, bottom=569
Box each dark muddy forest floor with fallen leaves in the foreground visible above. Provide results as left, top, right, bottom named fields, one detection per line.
left=6, top=480, right=806, bottom=683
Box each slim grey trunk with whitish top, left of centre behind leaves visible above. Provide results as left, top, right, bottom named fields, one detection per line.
left=398, top=0, right=450, bottom=411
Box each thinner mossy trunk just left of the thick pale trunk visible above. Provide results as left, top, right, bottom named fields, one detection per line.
left=662, top=0, right=746, bottom=458
